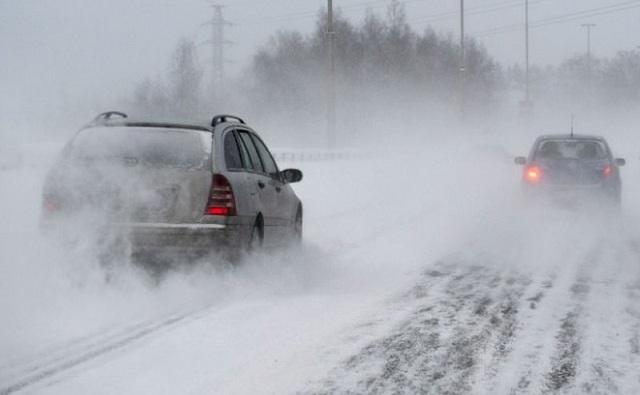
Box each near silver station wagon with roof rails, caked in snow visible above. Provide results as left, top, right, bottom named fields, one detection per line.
left=42, top=112, right=303, bottom=260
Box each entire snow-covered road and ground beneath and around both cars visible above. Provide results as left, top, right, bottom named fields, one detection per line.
left=0, top=141, right=640, bottom=394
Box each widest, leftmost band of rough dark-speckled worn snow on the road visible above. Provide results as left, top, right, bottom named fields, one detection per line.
left=318, top=266, right=530, bottom=393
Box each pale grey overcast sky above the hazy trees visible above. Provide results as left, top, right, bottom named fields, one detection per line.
left=0, top=0, right=640, bottom=124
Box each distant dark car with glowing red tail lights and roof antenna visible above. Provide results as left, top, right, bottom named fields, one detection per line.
left=515, top=134, right=625, bottom=205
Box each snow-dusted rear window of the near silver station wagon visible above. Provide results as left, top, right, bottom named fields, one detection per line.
left=70, top=127, right=211, bottom=168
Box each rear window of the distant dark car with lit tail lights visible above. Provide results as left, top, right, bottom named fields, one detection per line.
left=535, top=139, right=608, bottom=160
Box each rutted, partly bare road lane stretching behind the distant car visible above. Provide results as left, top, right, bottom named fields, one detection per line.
left=310, top=217, right=640, bottom=394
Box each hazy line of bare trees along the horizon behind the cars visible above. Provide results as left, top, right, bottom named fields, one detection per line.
left=130, top=0, right=640, bottom=128
